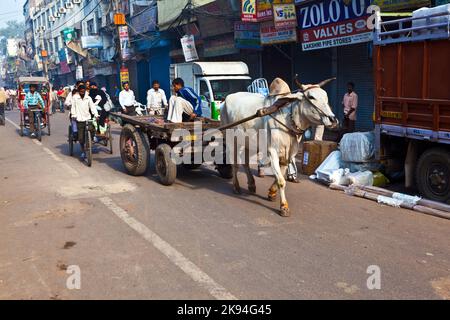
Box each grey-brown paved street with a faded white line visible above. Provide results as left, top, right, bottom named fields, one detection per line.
left=0, top=113, right=450, bottom=299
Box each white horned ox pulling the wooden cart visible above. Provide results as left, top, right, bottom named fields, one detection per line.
left=221, top=79, right=339, bottom=217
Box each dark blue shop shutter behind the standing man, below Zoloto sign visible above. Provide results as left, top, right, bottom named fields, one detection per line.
left=338, top=43, right=374, bottom=131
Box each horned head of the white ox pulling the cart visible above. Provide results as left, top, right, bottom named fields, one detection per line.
left=286, top=77, right=339, bottom=129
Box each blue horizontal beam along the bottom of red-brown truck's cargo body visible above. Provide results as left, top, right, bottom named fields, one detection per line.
left=380, top=124, right=450, bottom=144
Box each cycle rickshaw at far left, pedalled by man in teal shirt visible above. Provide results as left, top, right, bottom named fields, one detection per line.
left=17, top=77, right=51, bottom=141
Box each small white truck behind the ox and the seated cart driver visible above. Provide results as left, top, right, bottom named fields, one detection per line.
left=170, top=62, right=251, bottom=120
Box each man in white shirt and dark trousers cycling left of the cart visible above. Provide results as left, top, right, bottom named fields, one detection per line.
left=70, top=85, right=99, bottom=160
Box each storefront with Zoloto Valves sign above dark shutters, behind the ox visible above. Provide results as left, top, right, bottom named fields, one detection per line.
left=294, top=0, right=374, bottom=131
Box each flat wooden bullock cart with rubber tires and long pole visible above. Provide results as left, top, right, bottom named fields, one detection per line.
left=112, top=101, right=288, bottom=186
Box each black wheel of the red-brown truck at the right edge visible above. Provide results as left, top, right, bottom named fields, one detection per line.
left=416, top=148, right=450, bottom=202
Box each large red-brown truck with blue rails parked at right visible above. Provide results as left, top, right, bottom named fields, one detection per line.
left=374, top=6, right=450, bottom=202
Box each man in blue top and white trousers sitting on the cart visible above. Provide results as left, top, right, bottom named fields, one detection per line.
left=167, top=78, right=202, bottom=123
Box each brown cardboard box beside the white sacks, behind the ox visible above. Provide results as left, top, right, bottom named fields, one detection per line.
left=302, top=141, right=337, bottom=176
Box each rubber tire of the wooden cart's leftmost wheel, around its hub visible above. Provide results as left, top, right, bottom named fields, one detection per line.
left=120, top=124, right=150, bottom=176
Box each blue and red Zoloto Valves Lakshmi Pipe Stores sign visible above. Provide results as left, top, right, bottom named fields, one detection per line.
left=296, top=0, right=372, bottom=51
